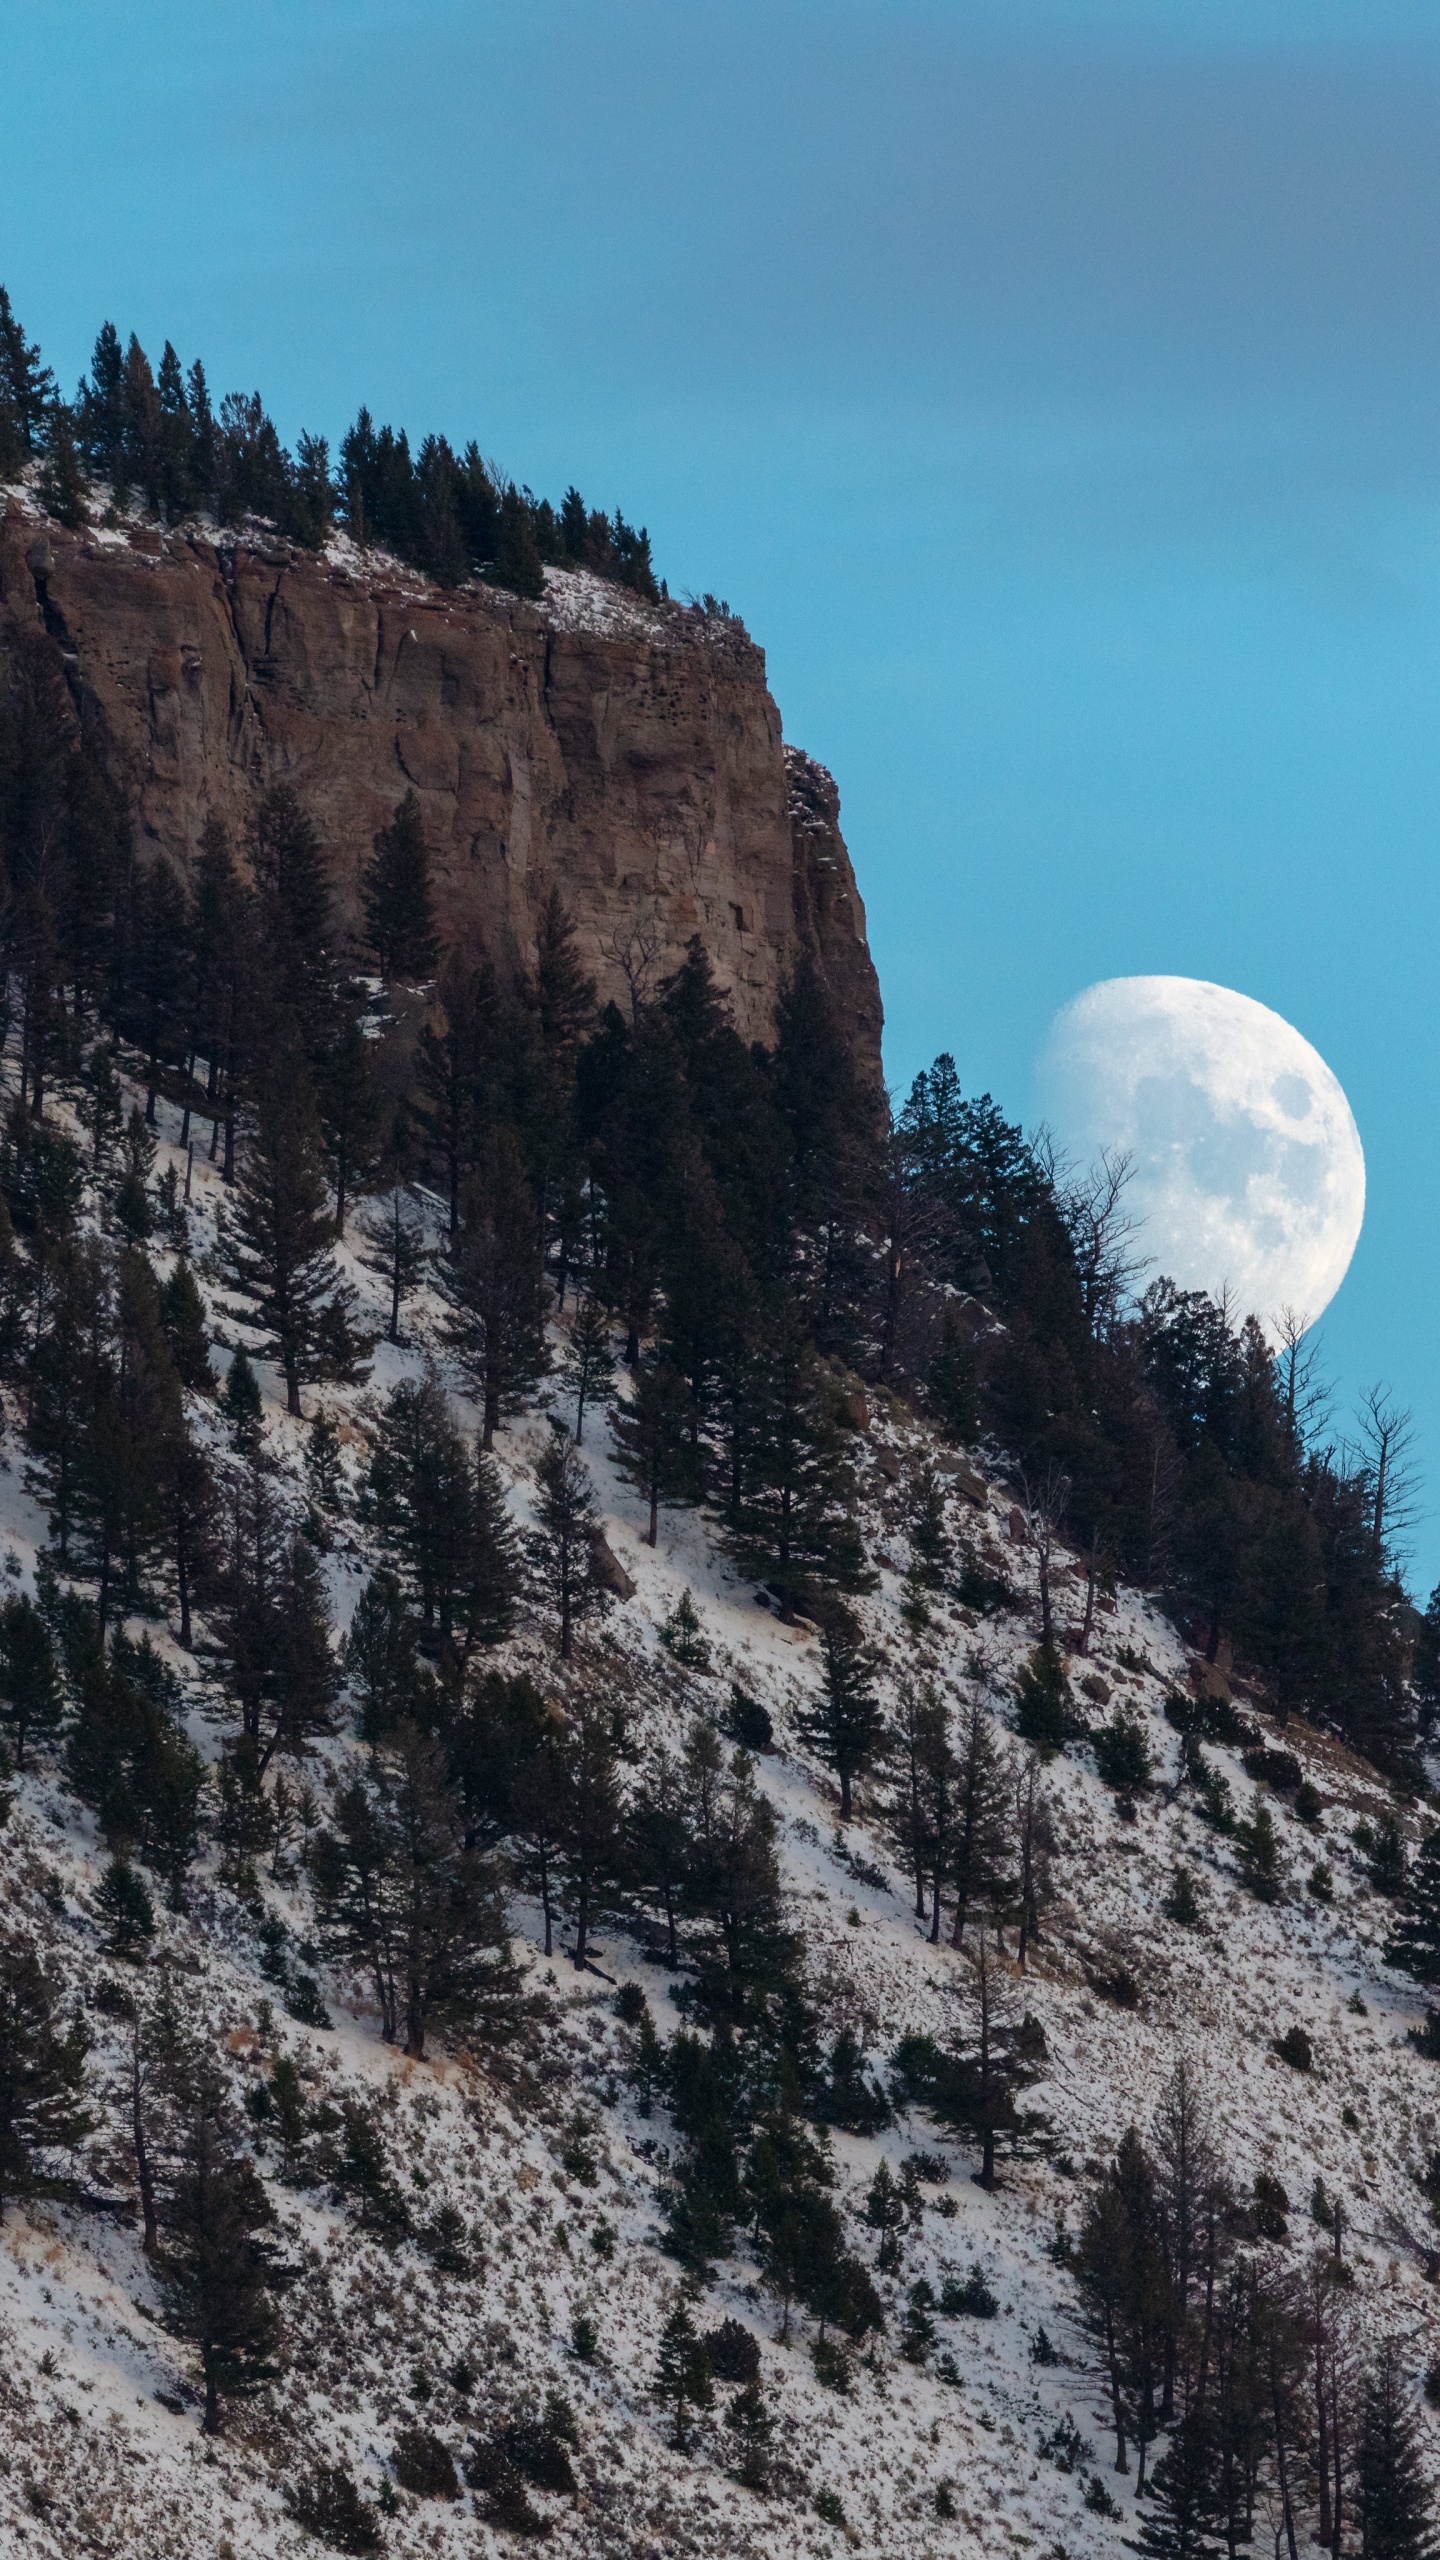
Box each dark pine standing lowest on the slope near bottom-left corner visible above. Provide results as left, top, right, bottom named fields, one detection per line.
left=156, top=2089, right=277, bottom=2435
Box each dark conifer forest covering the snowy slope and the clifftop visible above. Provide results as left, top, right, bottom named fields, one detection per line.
left=0, top=292, right=1440, bottom=2560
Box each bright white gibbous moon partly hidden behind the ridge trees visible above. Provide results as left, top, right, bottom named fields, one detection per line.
left=1040, top=978, right=1366, bottom=1341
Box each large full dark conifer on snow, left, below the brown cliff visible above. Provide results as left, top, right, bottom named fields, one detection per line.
left=218, top=1052, right=364, bottom=1416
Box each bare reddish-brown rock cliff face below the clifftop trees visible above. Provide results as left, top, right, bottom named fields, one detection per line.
left=0, top=504, right=881, bottom=1075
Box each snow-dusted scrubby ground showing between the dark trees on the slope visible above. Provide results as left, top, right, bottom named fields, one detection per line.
left=0, top=1070, right=1440, bottom=2560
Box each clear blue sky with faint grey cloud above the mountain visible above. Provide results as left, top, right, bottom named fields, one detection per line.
left=0, top=0, right=1440, bottom=1587
